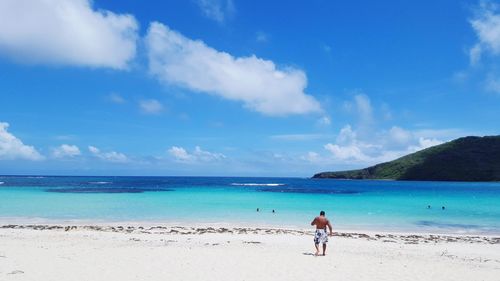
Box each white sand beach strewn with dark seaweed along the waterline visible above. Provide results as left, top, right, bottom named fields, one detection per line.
left=0, top=225, right=500, bottom=281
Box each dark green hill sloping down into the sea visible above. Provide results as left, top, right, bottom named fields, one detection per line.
left=313, top=136, right=500, bottom=181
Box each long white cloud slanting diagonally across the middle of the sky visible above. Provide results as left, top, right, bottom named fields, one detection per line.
left=146, top=22, right=321, bottom=115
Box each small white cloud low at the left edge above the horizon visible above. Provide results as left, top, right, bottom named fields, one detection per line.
left=0, top=122, right=43, bottom=160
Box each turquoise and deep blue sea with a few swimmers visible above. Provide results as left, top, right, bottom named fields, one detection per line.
left=0, top=176, right=500, bottom=234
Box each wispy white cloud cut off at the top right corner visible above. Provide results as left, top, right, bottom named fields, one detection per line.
left=469, top=1, right=500, bottom=64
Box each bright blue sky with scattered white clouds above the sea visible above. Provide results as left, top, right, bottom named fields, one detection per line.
left=0, top=0, right=500, bottom=176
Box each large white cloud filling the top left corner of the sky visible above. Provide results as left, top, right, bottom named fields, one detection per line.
left=0, top=0, right=138, bottom=69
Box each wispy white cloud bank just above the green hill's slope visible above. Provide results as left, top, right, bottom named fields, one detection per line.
left=301, top=94, right=456, bottom=167
